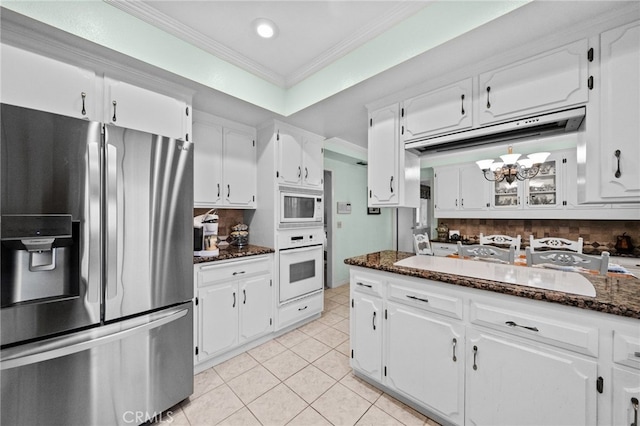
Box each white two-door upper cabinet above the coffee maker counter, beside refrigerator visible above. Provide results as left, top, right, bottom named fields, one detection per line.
left=193, top=112, right=257, bottom=209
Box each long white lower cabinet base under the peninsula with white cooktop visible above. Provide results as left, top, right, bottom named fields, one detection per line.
left=350, top=267, right=640, bottom=426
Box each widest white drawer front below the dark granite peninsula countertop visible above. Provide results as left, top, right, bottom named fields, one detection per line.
left=469, top=301, right=598, bottom=357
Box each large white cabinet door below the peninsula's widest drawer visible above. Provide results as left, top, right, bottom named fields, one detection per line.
left=465, top=330, right=597, bottom=426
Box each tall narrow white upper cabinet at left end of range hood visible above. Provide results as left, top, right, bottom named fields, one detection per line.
left=367, top=104, right=420, bottom=207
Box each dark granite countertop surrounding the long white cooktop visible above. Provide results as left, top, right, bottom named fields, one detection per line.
left=344, top=250, right=640, bottom=319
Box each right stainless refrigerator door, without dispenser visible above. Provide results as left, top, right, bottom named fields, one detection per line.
left=105, top=125, right=193, bottom=321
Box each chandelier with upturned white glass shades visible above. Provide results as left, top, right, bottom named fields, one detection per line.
left=476, top=146, right=550, bottom=184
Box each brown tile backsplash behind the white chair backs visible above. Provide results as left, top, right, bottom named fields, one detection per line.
left=434, top=219, right=640, bottom=256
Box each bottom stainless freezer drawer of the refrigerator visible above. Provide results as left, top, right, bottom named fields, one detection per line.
left=0, top=302, right=193, bottom=425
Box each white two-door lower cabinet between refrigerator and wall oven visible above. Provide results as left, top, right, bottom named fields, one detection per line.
left=194, top=255, right=275, bottom=363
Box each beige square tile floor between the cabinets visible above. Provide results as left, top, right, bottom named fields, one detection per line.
left=162, top=285, right=437, bottom=426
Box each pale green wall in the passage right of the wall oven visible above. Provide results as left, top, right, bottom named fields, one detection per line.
left=324, top=156, right=393, bottom=287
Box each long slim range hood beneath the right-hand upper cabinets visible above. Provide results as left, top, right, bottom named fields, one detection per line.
left=405, top=107, right=586, bottom=153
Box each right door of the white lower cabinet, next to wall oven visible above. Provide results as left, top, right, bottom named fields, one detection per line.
left=238, top=275, right=273, bottom=344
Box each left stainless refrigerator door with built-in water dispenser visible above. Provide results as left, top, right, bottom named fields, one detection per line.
left=0, top=104, right=102, bottom=346
